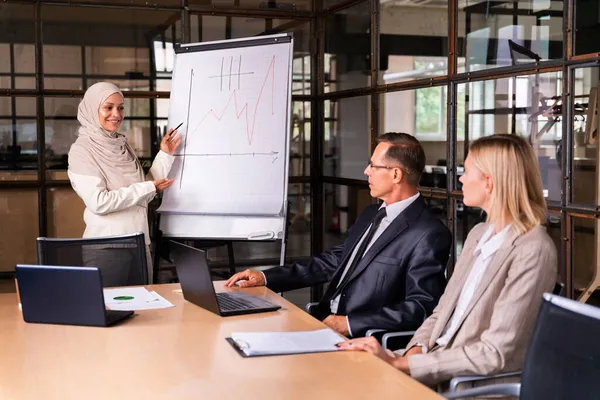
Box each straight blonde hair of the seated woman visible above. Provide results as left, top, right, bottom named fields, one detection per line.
left=469, top=134, right=548, bottom=233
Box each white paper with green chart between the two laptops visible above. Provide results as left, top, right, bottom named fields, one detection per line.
left=104, top=288, right=174, bottom=311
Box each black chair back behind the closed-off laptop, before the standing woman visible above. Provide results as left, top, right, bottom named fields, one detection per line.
left=37, top=232, right=148, bottom=287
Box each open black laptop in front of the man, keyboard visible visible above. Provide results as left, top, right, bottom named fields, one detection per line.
left=171, top=241, right=281, bottom=317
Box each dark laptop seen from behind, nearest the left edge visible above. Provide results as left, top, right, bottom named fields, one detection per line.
left=16, top=264, right=133, bottom=326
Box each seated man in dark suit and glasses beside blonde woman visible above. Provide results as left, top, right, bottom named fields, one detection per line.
left=226, top=133, right=452, bottom=337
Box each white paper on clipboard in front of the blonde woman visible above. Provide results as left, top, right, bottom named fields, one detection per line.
left=231, top=329, right=344, bottom=356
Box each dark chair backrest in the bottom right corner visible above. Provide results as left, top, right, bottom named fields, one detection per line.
left=520, top=293, right=600, bottom=400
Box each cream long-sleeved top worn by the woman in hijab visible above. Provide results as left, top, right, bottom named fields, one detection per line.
left=68, top=151, right=175, bottom=246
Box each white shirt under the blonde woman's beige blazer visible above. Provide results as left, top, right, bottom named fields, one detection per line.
left=434, top=225, right=511, bottom=353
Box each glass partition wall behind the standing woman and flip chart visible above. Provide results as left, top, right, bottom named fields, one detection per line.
left=0, top=0, right=315, bottom=288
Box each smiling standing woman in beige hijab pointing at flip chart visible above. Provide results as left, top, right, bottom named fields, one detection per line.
left=68, top=82, right=181, bottom=286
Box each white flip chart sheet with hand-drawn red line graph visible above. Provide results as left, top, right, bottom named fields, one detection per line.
left=159, top=35, right=291, bottom=215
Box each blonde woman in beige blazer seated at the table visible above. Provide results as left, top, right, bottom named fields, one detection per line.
left=339, top=135, right=557, bottom=385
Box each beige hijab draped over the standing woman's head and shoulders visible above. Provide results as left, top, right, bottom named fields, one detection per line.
left=69, top=82, right=144, bottom=190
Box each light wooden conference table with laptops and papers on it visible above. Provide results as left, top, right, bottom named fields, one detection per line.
left=0, top=282, right=441, bottom=400
